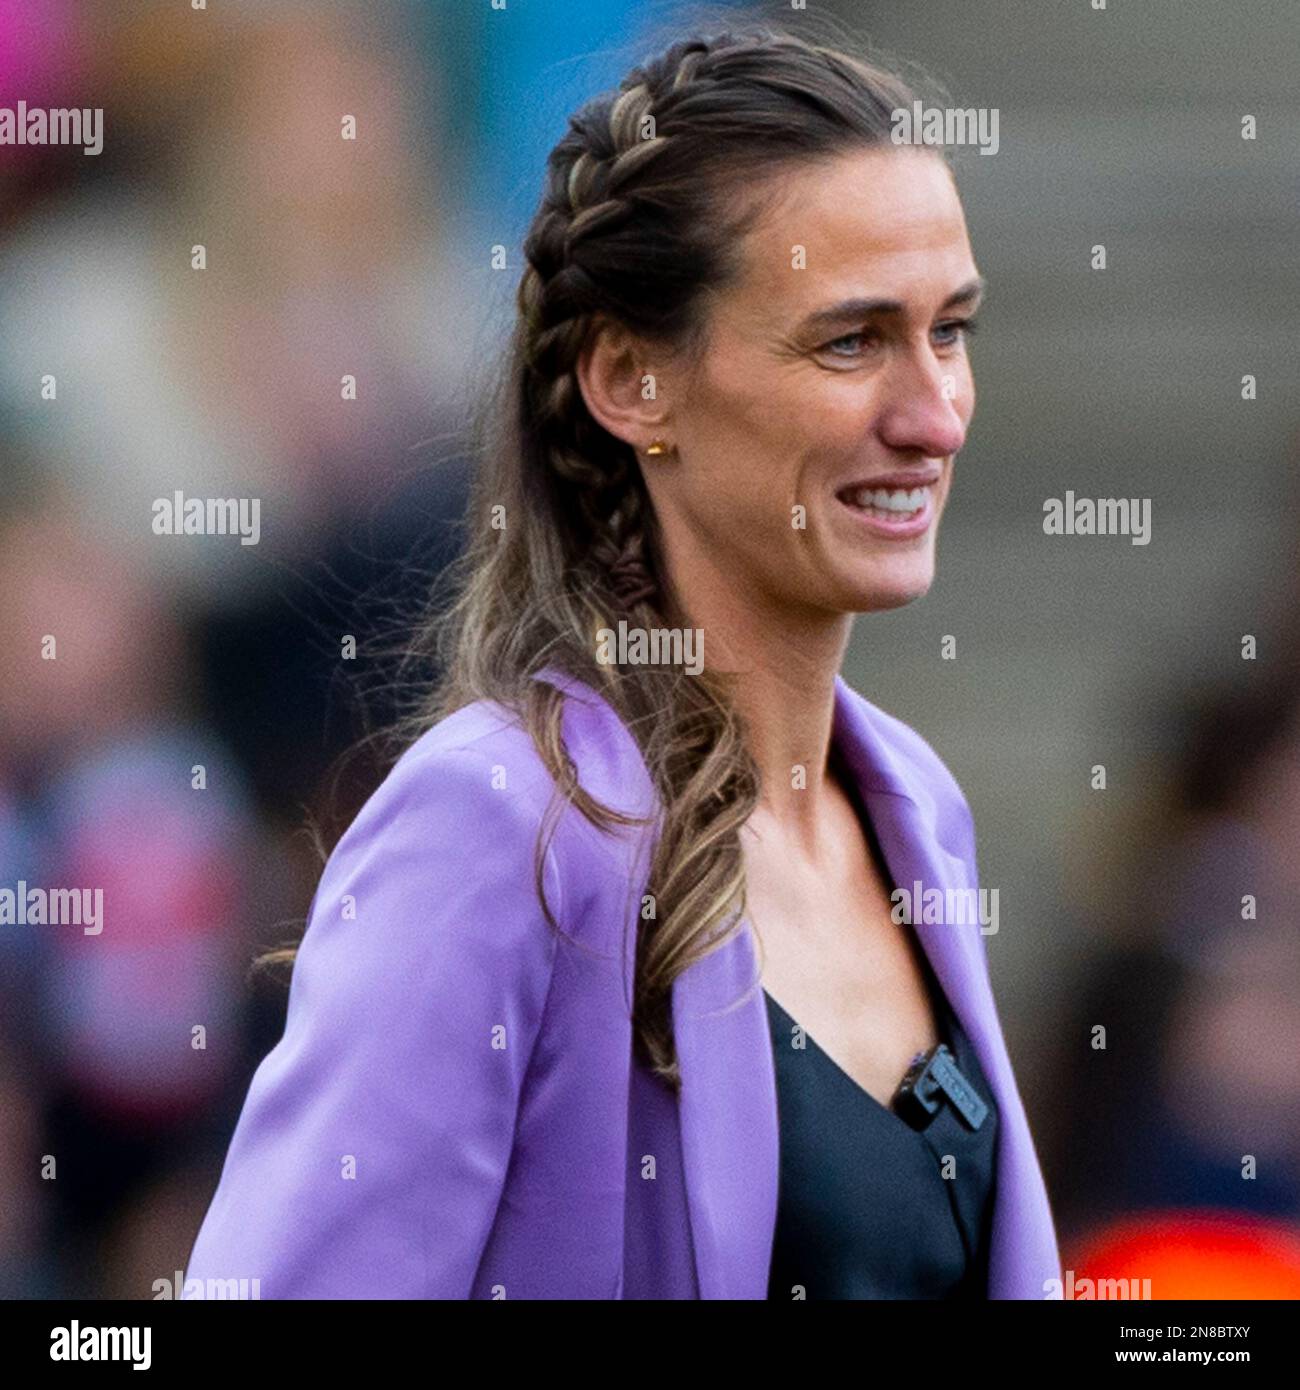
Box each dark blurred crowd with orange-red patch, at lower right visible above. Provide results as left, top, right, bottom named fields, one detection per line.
left=1036, top=636, right=1300, bottom=1298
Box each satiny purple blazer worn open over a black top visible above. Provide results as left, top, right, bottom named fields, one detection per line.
left=186, top=671, right=1061, bottom=1298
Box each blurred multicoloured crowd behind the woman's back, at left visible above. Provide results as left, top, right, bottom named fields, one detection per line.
left=0, top=0, right=473, bottom=1298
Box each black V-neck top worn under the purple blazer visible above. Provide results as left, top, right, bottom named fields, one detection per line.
left=763, top=970, right=998, bottom=1298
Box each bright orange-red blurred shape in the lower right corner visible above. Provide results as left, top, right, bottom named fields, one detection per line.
left=1066, top=1211, right=1300, bottom=1300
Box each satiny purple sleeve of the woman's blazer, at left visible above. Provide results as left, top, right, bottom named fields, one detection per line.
left=186, top=735, right=563, bottom=1298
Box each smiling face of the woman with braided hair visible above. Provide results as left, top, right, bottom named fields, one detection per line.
left=641, top=146, right=979, bottom=613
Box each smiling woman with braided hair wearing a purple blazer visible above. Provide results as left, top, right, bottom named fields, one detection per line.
left=189, top=28, right=1059, bottom=1298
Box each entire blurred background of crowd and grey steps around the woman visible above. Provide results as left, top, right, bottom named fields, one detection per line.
left=0, top=0, right=1300, bottom=1298
